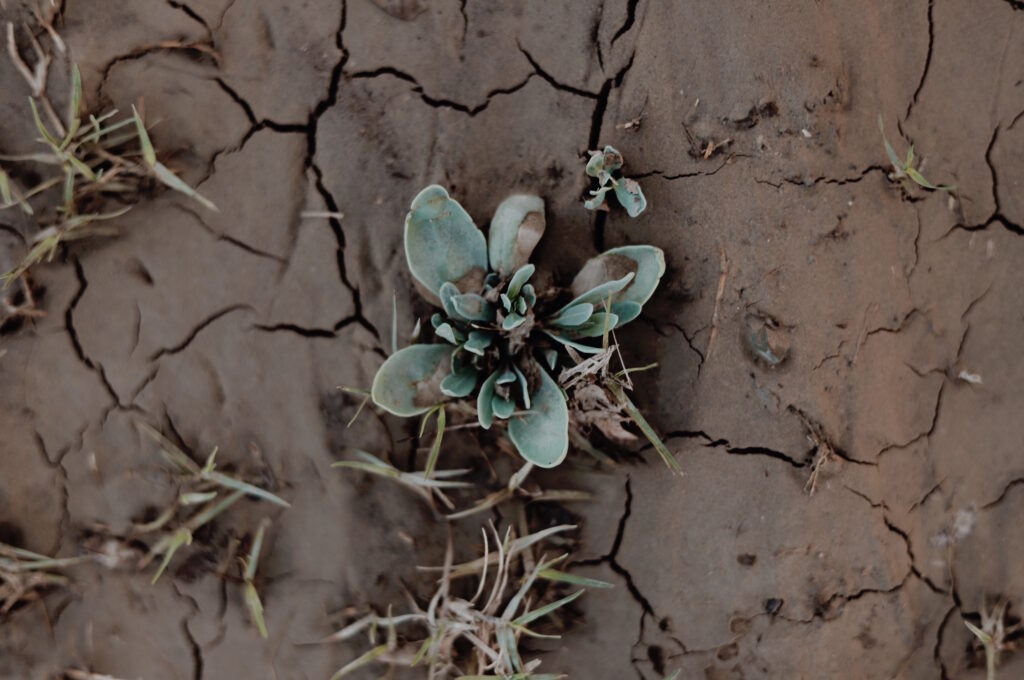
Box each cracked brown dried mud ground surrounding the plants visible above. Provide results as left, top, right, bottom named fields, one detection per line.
left=0, top=0, right=1024, bottom=680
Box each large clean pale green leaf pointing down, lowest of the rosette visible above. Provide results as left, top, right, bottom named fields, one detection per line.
left=509, top=367, right=569, bottom=468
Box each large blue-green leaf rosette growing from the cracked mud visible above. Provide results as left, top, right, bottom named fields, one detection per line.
left=371, top=185, right=665, bottom=474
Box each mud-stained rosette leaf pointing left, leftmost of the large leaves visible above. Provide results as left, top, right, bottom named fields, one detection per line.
left=370, top=344, right=452, bottom=417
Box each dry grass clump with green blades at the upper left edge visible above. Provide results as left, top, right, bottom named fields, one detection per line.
left=0, top=19, right=216, bottom=285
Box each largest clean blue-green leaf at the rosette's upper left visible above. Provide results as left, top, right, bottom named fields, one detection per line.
left=404, top=184, right=487, bottom=296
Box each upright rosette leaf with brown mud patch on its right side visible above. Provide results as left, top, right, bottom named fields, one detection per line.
left=487, top=194, right=545, bottom=274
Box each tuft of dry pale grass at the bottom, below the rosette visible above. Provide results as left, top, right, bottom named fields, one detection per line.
left=325, top=525, right=611, bottom=680
